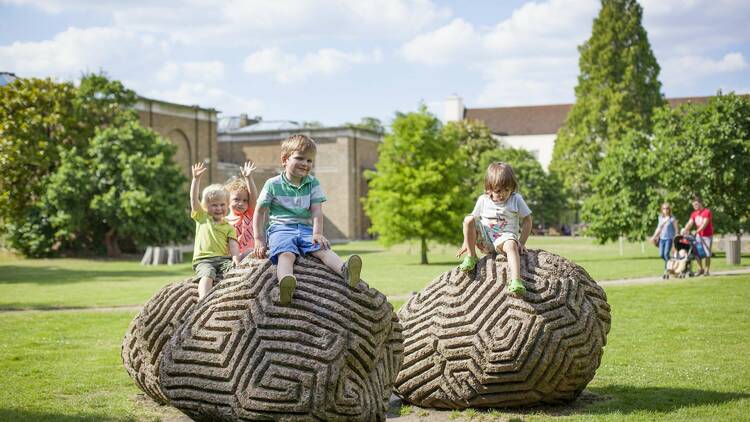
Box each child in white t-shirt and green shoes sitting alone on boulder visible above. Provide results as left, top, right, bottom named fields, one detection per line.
left=456, top=162, right=531, bottom=295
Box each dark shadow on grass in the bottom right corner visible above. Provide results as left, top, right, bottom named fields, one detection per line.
left=573, top=385, right=750, bottom=415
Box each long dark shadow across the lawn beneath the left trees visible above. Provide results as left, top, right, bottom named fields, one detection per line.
left=0, top=265, right=188, bottom=285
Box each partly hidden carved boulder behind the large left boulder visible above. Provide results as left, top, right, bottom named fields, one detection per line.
left=121, top=280, right=198, bottom=404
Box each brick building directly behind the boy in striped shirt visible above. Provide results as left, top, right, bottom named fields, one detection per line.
left=218, top=116, right=382, bottom=240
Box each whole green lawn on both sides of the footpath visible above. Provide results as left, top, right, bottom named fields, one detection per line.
left=0, top=237, right=750, bottom=421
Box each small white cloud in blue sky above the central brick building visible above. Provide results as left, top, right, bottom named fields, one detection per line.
left=242, top=47, right=382, bottom=83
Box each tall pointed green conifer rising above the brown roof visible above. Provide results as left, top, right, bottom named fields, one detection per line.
left=550, top=0, right=664, bottom=201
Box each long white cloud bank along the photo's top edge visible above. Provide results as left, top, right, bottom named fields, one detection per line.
left=7, top=0, right=451, bottom=46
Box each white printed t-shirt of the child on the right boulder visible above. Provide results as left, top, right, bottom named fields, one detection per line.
left=471, top=192, right=531, bottom=235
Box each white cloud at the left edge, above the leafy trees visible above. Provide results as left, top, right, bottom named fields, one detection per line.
left=0, top=28, right=167, bottom=78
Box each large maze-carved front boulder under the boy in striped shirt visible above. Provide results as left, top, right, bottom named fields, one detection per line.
left=123, top=258, right=403, bottom=421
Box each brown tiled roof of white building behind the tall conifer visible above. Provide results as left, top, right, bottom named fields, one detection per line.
left=464, top=97, right=711, bottom=136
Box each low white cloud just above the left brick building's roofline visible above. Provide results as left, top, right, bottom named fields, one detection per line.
left=145, top=82, right=263, bottom=115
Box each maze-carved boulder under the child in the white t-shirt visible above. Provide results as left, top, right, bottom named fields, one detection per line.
left=396, top=250, right=610, bottom=409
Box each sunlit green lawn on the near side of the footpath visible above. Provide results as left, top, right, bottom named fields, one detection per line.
left=0, top=275, right=750, bottom=421
